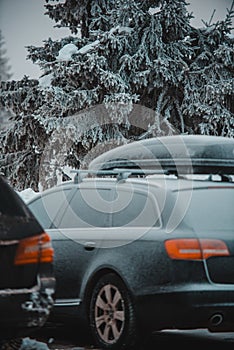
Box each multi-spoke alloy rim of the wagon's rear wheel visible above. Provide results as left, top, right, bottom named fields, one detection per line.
left=95, top=284, right=125, bottom=344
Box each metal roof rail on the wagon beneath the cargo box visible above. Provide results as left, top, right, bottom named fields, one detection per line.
left=71, top=168, right=170, bottom=184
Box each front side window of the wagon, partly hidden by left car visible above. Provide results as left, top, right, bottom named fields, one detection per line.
left=28, top=189, right=71, bottom=229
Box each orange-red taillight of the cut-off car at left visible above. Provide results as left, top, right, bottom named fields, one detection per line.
left=15, top=233, right=54, bottom=265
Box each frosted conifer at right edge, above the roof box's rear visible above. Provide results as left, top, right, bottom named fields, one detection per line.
left=181, top=2, right=234, bottom=137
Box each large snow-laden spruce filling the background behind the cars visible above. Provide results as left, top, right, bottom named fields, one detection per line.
left=0, top=0, right=231, bottom=190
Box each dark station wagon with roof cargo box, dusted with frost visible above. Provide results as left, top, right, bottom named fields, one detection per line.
left=28, top=136, right=234, bottom=350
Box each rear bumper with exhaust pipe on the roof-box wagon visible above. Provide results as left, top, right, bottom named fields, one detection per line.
left=136, top=286, right=234, bottom=332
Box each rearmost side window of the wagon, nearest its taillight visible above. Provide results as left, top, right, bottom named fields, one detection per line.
left=112, top=189, right=160, bottom=227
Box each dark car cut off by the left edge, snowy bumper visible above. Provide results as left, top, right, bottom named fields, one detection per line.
left=0, top=176, right=55, bottom=344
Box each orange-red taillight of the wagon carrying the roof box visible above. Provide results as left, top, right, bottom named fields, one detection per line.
left=165, top=238, right=230, bottom=260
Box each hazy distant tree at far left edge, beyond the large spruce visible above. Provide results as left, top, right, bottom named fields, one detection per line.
left=0, top=31, right=11, bottom=132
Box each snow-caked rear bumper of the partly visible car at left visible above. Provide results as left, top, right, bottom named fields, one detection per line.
left=0, top=277, right=55, bottom=339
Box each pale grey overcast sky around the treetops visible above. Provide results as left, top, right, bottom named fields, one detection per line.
left=0, top=0, right=232, bottom=80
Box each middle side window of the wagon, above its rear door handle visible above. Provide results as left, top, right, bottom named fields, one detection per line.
left=59, top=188, right=111, bottom=228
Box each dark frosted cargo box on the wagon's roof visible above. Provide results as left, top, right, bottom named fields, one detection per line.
left=89, top=135, right=234, bottom=174
